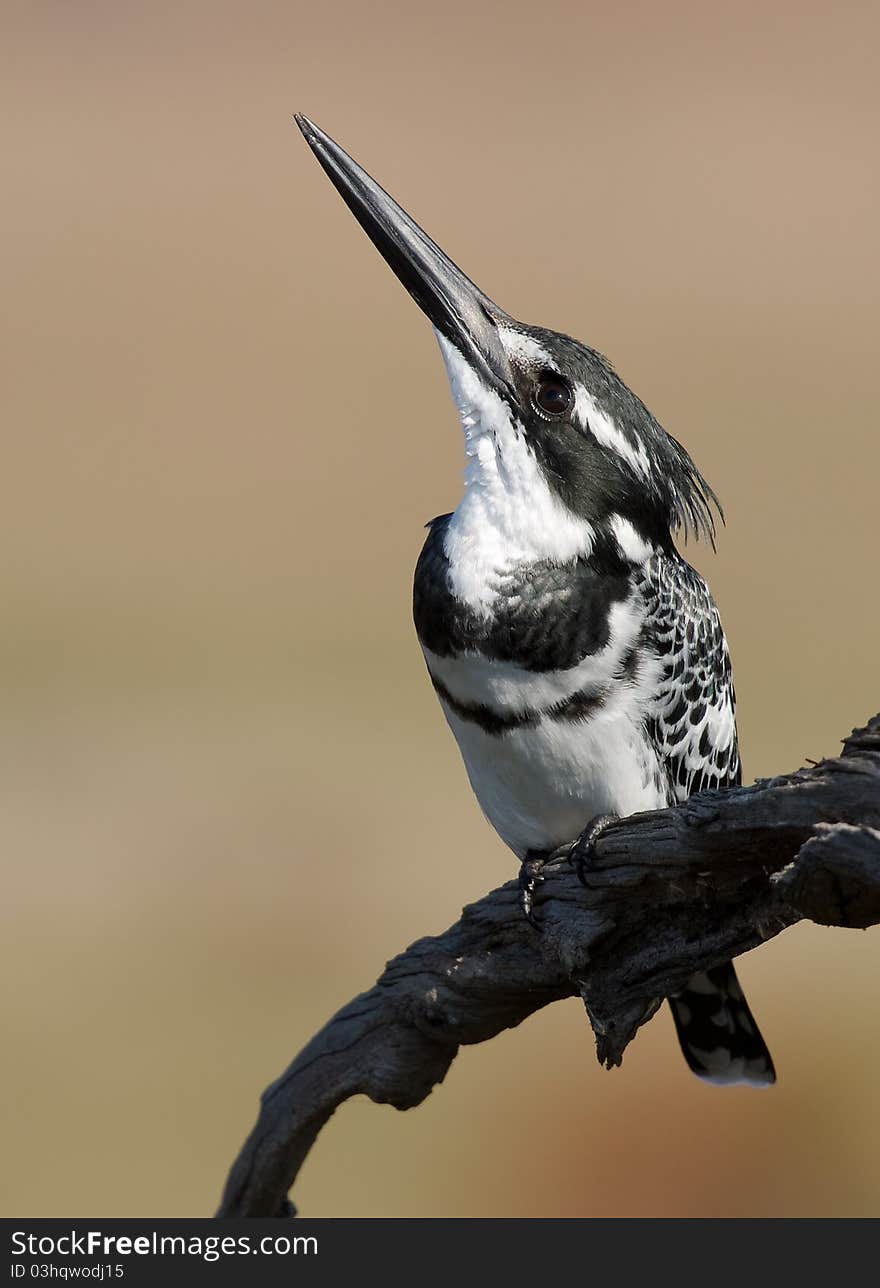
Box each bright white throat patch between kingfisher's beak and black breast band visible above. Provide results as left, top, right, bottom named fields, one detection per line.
left=435, top=332, right=595, bottom=616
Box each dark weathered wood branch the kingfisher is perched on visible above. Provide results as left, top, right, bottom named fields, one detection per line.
left=219, top=716, right=880, bottom=1217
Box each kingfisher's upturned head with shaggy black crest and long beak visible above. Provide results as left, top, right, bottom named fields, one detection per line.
left=296, top=116, right=720, bottom=559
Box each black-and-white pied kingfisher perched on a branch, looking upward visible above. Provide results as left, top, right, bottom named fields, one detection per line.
left=295, top=113, right=776, bottom=1086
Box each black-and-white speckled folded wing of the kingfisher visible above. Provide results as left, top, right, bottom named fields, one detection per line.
left=644, top=555, right=742, bottom=805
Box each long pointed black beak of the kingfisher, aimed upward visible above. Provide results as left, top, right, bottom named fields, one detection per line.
left=295, top=115, right=515, bottom=403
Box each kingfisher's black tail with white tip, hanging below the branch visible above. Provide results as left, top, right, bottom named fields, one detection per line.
left=669, top=962, right=776, bottom=1087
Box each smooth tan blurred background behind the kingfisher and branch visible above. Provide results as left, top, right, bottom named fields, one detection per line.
left=0, top=0, right=880, bottom=1216
